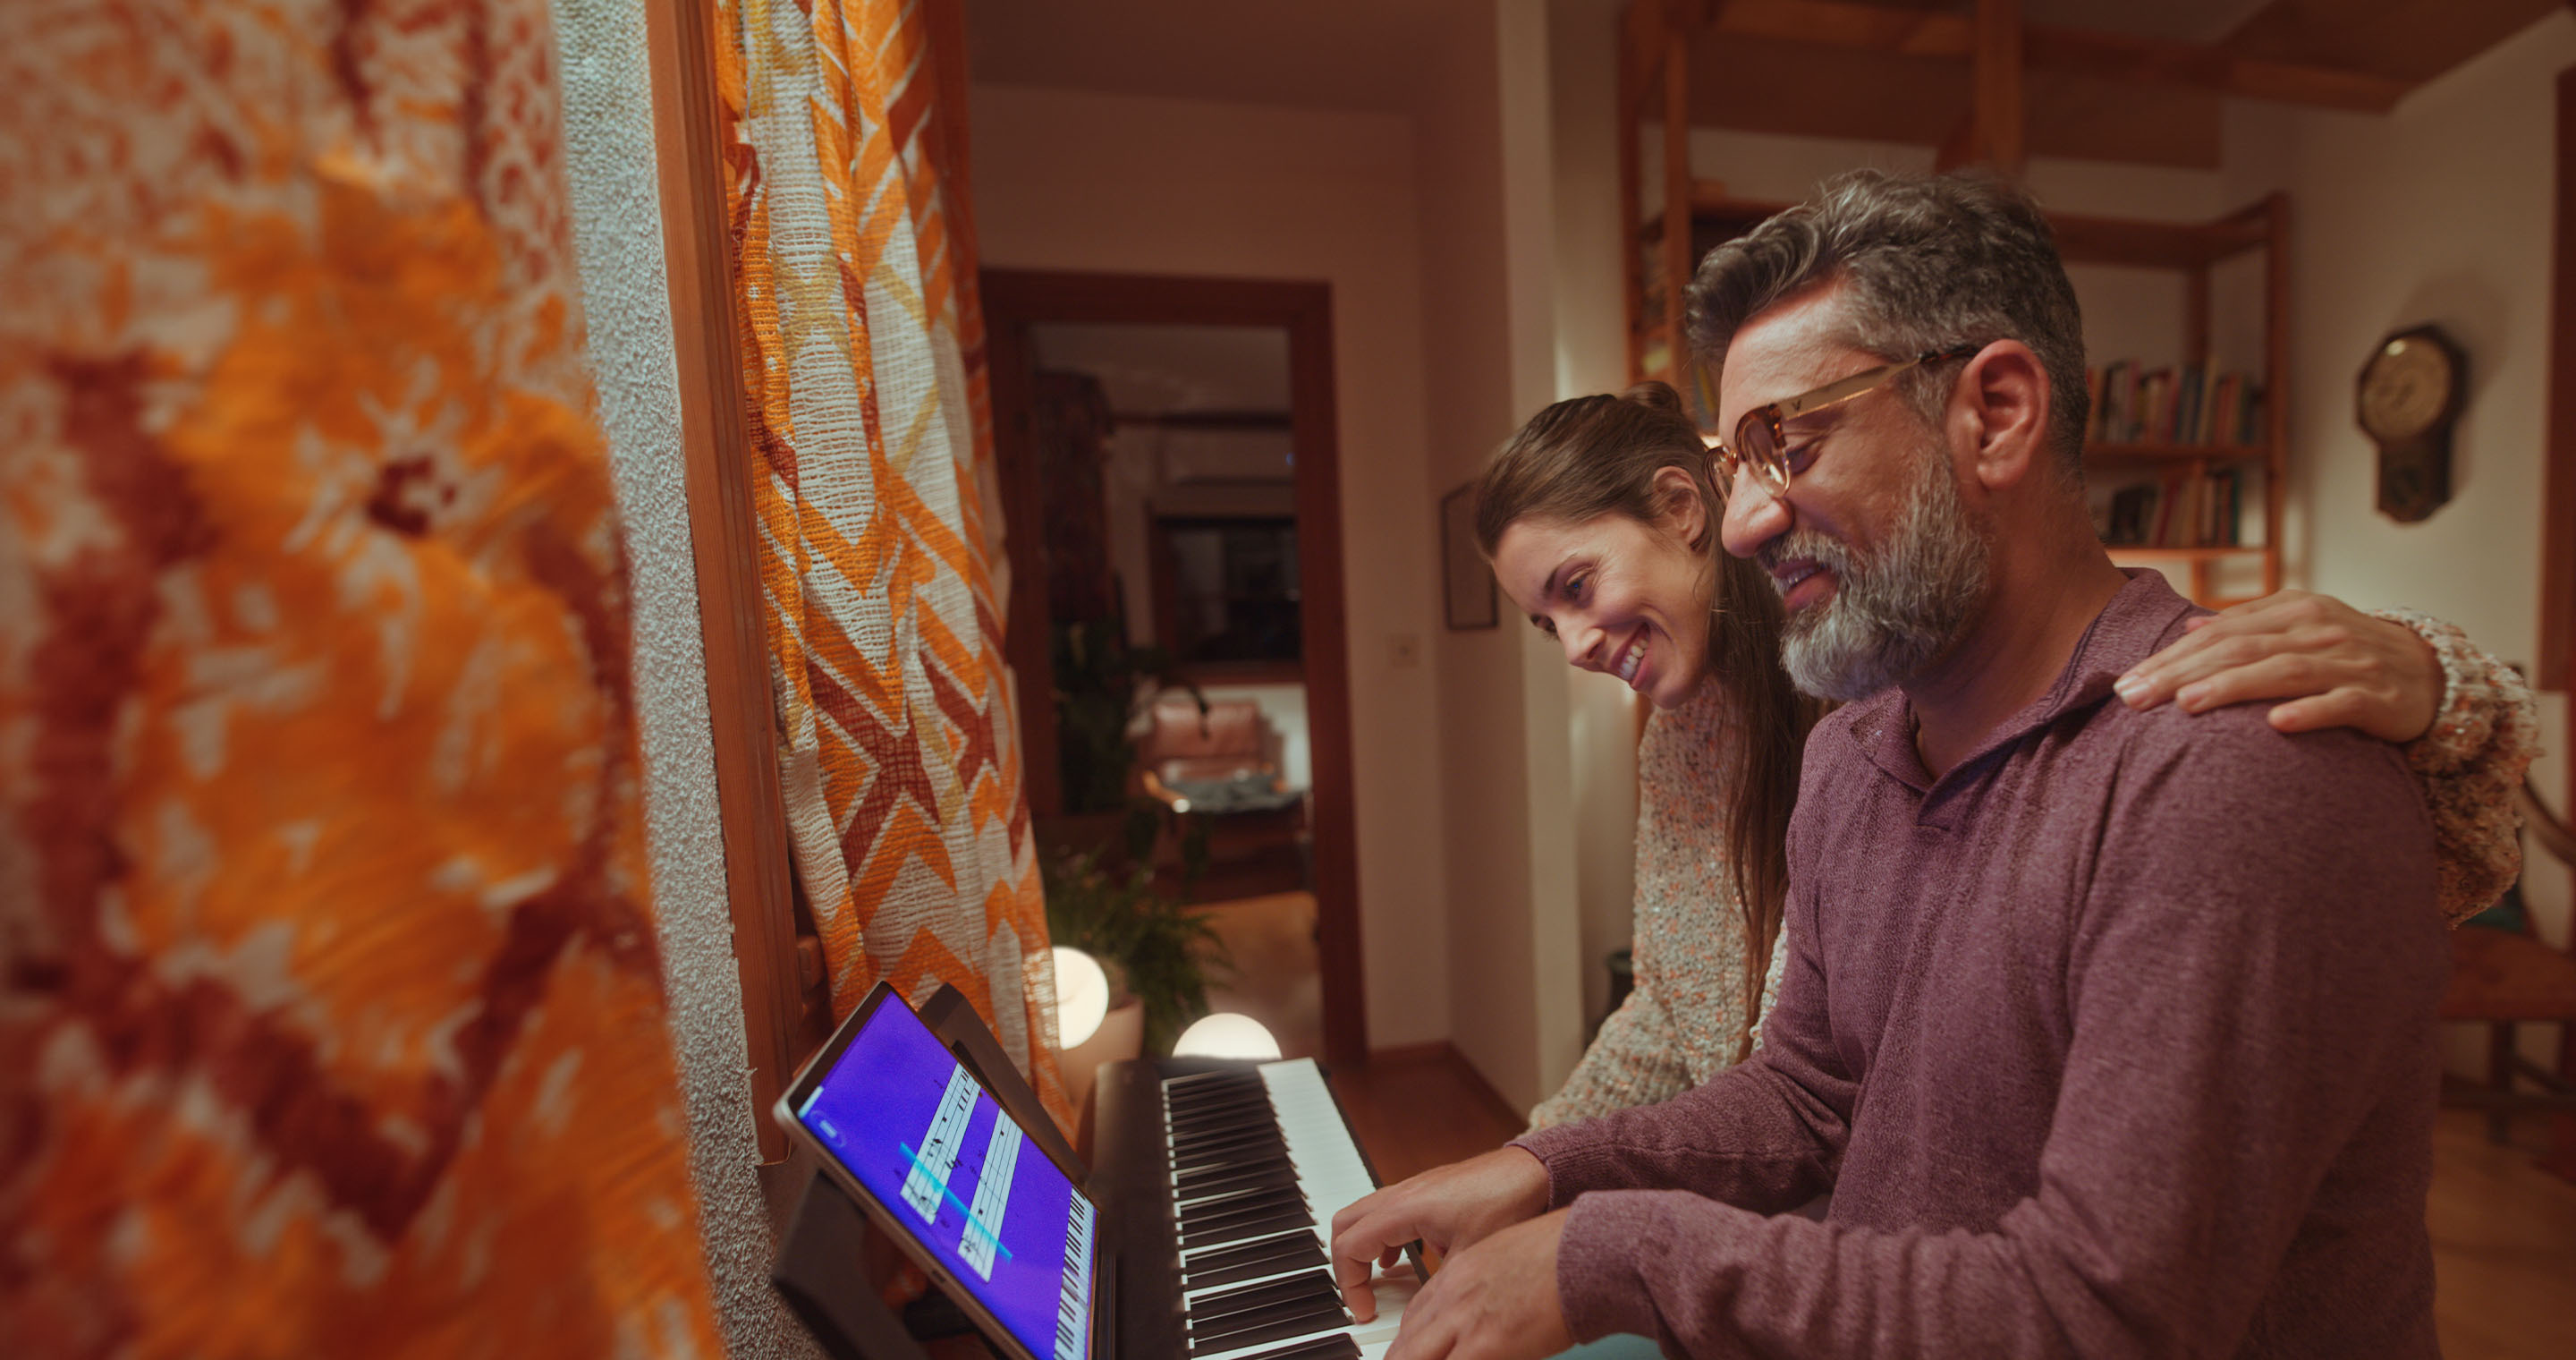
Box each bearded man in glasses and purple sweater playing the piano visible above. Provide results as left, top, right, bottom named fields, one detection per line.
left=1335, top=173, right=2447, bottom=1360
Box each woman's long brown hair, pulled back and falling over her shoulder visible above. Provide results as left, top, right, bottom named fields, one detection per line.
left=1476, top=381, right=1824, bottom=1061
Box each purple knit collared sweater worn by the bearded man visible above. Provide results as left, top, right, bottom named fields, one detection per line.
left=1520, top=572, right=2447, bottom=1357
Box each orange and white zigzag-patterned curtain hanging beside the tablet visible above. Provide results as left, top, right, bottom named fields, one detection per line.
left=716, top=0, right=1069, bottom=1120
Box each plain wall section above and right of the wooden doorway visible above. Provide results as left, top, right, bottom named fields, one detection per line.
left=971, top=85, right=1450, bottom=1046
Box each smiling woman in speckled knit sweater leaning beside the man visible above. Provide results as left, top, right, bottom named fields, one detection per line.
left=1476, top=384, right=2535, bottom=1126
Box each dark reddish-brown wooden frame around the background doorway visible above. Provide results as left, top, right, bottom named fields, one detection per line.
left=981, top=268, right=1368, bottom=1064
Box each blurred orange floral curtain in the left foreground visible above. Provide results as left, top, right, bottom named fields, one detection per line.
left=0, top=0, right=716, bottom=1357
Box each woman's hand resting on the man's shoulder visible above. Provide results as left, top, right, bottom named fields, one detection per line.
left=2114, top=590, right=2442, bottom=742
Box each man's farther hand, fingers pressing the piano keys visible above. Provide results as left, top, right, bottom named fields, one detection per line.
left=1332, top=1149, right=1556, bottom=1318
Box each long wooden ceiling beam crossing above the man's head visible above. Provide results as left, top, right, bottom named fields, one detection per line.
left=1707, top=0, right=2414, bottom=114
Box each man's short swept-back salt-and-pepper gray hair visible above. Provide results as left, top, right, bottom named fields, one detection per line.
left=1687, top=170, right=2092, bottom=484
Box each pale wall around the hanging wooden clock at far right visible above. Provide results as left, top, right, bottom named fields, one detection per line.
left=2228, top=11, right=2576, bottom=994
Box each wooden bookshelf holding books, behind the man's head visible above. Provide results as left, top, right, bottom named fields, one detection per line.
left=1628, top=178, right=2290, bottom=608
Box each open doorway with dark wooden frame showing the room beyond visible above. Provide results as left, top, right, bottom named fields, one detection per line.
left=981, top=270, right=1368, bottom=1064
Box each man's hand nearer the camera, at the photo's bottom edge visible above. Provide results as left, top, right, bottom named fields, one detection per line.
left=1385, top=1208, right=1574, bottom=1360
